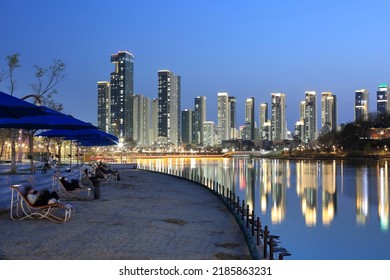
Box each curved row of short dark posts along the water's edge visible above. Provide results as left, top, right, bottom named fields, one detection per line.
left=139, top=166, right=290, bottom=260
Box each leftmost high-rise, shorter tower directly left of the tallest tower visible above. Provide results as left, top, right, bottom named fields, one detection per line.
left=97, top=81, right=110, bottom=134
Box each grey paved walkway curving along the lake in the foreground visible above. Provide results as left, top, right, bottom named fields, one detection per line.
left=0, top=170, right=251, bottom=260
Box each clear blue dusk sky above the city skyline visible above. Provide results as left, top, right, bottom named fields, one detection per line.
left=0, top=0, right=390, bottom=130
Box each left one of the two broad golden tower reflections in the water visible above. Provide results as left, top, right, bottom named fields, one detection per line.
left=297, top=160, right=318, bottom=226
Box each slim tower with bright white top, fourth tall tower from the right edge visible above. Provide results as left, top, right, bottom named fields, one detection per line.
left=305, top=91, right=317, bottom=143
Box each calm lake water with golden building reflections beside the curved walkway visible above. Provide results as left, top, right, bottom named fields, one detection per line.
left=138, top=158, right=390, bottom=260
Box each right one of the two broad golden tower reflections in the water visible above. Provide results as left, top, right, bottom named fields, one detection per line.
left=321, top=160, right=337, bottom=225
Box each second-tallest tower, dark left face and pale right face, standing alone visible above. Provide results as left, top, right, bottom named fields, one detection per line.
left=158, top=70, right=181, bottom=146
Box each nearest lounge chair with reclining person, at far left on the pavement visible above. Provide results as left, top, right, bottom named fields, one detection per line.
left=10, top=185, right=74, bottom=223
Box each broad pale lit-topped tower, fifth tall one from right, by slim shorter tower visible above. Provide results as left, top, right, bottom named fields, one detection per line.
left=271, top=93, right=287, bottom=141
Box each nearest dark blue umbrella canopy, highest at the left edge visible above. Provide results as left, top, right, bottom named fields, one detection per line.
left=0, top=91, right=49, bottom=119
